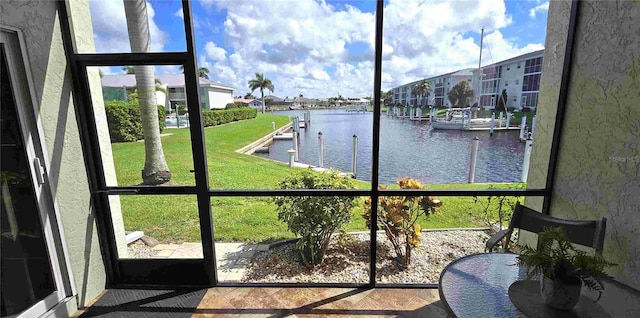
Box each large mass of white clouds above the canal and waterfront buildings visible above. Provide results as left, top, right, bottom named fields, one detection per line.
left=199, top=0, right=543, bottom=97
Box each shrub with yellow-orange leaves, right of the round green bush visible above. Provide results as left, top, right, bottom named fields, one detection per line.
left=362, top=177, right=442, bottom=268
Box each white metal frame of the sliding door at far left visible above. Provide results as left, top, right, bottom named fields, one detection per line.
left=0, top=24, right=77, bottom=317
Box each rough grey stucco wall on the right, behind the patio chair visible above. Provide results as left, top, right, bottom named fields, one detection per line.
left=524, top=0, right=640, bottom=289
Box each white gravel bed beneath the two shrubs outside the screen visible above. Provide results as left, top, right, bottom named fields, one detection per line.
left=242, top=230, right=489, bottom=284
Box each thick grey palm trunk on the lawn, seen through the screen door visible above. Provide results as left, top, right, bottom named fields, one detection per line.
left=124, top=0, right=171, bottom=185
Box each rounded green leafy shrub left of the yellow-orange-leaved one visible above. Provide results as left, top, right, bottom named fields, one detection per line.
left=274, top=169, right=355, bottom=267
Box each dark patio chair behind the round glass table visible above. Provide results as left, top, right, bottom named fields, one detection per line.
left=486, top=202, right=607, bottom=255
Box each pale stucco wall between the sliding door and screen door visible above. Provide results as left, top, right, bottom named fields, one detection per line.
left=0, top=1, right=105, bottom=305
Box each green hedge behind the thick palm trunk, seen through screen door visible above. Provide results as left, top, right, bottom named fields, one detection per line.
left=104, top=101, right=166, bottom=142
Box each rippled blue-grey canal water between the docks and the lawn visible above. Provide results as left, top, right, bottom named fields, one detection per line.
left=256, top=109, right=524, bottom=184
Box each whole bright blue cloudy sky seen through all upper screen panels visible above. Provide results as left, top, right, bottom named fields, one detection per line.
left=90, top=0, right=548, bottom=97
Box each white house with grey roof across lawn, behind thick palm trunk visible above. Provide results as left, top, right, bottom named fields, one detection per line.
left=102, top=74, right=234, bottom=110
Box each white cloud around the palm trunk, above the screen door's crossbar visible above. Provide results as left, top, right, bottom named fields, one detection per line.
left=89, top=0, right=168, bottom=53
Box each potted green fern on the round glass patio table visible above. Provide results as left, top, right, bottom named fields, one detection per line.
left=517, top=227, right=616, bottom=310
